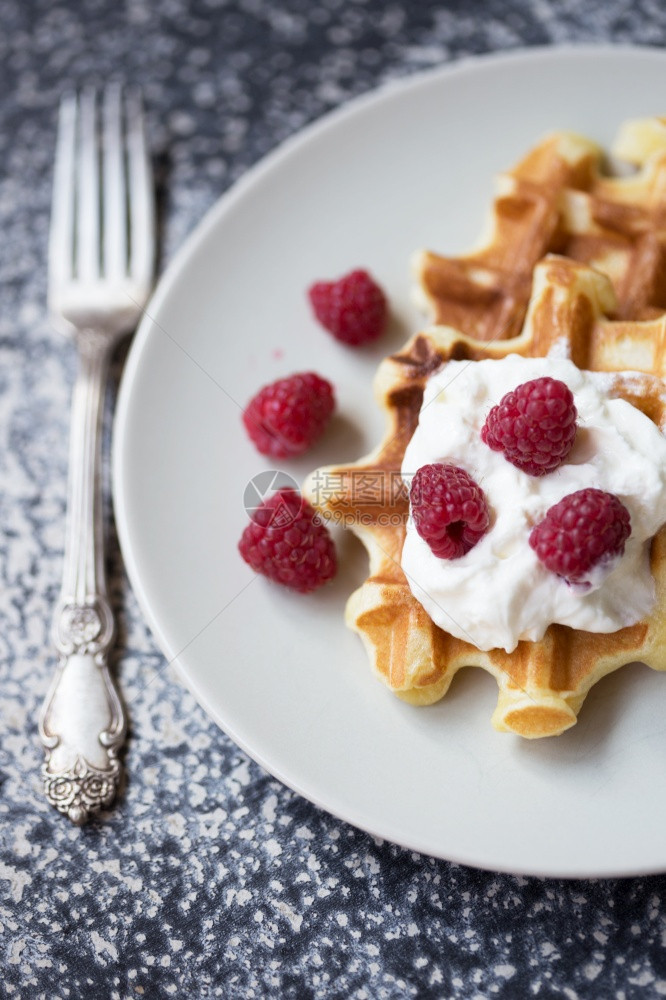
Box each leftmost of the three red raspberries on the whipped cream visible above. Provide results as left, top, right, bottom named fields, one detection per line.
left=409, top=464, right=490, bottom=559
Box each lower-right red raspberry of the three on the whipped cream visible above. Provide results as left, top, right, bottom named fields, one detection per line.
left=530, top=488, right=631, bottom=583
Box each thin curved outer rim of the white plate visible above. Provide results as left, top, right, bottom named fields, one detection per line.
left=115, top=42, right=666, bottom=880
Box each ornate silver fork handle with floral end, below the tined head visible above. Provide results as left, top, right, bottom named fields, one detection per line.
left=39, top=330, right=126, bottom=825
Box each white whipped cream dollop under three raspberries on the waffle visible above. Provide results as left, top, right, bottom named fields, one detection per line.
left=402, top=355, right=666, bottom=652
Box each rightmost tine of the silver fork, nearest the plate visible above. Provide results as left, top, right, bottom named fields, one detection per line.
left=126, top=92, right=155, bottom=287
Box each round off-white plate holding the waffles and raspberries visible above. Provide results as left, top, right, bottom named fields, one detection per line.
left=114, top=48, right=666, bottom=876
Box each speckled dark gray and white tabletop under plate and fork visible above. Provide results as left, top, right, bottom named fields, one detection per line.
left=0, top=0, right=666, bottom=1000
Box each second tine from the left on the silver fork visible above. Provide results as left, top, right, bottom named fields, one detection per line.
left=76, top=90, right=100, bottom=281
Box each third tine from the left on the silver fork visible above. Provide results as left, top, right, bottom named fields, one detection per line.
left=102, top=84, right=127, bottom=278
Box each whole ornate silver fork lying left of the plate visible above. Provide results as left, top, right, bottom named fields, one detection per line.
left=39, top=85, right=155, bottom=824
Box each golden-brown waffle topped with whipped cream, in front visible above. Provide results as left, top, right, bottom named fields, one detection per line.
left=304, top=256, right=666, bottom=737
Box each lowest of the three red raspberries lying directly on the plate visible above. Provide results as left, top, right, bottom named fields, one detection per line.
left=238, top=488, right=337, bottom=594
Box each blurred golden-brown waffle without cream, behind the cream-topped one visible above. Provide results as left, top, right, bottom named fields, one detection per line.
left=414, top=118, right=666, bottom=340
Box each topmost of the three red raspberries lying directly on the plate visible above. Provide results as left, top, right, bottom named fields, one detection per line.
left=308, top=270, right=388, bottom=346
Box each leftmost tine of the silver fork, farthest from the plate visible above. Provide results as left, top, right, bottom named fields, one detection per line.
left=48, top=94, right=77, bottom=300
